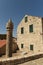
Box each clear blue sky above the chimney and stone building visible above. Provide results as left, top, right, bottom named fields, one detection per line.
left=0, top=0, right=43, bottom=36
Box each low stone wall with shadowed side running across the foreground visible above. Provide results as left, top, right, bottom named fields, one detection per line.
left=0, top=54, right=43, bottom=65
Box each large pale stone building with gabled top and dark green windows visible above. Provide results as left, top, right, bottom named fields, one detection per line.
left=17, top=15, right=43, bottom=53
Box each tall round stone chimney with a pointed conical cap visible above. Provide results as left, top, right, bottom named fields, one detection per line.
left=6, top=19, right=13, bottom=57
